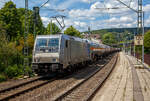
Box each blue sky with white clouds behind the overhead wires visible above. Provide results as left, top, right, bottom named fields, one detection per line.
left=0, top=0, right=150, bottom=31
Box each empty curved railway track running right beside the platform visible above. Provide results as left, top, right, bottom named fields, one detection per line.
left=55, top=55, right=118, bottom=101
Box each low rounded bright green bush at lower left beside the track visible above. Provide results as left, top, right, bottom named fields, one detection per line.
left=5, top=65, right=23, bottom=78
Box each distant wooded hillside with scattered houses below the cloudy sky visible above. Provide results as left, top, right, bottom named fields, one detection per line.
left=87, top=27, right=150, bottom=45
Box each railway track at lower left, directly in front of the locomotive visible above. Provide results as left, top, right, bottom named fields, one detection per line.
left=0, top=76, right=56, bottom=101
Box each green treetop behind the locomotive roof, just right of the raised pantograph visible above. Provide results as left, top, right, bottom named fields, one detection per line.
left=64, top=26, right=81, bottom=37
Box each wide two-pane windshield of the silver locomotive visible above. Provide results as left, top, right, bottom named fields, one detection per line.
left=35, top=38, right=59, bottom=53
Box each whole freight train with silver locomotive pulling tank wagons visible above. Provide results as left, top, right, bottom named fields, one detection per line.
left=32, top=34, right=118, bottom=73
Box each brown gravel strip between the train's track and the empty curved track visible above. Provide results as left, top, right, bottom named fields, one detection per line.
left=11, top=56, right=112, bottom=101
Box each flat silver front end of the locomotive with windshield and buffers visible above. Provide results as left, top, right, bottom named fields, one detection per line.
left=32, top=35, right=61, bottom=73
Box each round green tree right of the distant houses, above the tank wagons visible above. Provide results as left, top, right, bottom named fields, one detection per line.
left=102, top=33, right=116, bottom=45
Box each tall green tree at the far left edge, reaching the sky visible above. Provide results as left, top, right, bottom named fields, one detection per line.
left=0, top=1, right=21, bottom=39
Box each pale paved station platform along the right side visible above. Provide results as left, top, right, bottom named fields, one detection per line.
left=93, top=52, right=150, bottom=101
